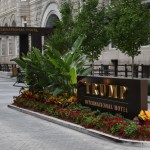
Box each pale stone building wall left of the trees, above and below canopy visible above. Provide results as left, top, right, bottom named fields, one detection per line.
left=0, top=0, right=61, bottom=64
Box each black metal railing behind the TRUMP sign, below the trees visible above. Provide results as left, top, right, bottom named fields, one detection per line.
left=84, top=64, right=150, bottom=78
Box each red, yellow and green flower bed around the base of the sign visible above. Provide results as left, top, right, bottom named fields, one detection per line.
left=13, top=91, right=150, bottom=141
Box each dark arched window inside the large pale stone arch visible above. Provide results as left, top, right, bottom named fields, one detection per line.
left=46, top=14, right=59, bottom=28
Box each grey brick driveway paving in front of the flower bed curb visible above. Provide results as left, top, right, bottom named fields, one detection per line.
left=0, top=78, right=150, bottom=150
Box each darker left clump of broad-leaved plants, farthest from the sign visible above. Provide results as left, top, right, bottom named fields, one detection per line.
left=15, top=48, right=50, bottom=92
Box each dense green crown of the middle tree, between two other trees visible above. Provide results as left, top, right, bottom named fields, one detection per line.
left=74, top=0, right=109, bottom=61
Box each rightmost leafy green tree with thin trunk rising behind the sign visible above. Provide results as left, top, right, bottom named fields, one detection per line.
left=107, top=0, right=150, bottom=78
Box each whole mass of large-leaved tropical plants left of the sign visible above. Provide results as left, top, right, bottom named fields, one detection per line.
left=15, top=36, right=92, bottom=96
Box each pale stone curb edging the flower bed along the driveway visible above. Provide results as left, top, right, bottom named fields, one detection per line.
left=8, top=105, right=150, bottom=147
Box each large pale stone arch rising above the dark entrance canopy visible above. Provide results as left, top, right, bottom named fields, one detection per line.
left=41, top=3, right=61, bottom=27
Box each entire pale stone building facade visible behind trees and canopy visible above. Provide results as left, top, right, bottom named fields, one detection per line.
left=0, top=0, right=150, bottom=65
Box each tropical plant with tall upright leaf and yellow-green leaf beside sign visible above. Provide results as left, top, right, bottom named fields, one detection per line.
left=45, top=36, right=92, bottom=95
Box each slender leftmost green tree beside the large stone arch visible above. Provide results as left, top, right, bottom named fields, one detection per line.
left=47, top=1, right=77, bottom=54
